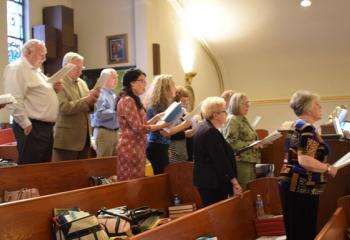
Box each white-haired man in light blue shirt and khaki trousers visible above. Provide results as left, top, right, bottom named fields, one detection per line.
left=92, top=68, right=119, bottom=157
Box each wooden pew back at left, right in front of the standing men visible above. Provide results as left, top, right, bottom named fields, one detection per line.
left=0, top=157, right=117, bottom=196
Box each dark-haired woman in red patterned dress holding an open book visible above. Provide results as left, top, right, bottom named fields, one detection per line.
left=117, top=69, right=167, bottom=181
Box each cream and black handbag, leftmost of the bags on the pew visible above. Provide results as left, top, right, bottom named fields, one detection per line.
left=54, top=214, right=109, bottom=240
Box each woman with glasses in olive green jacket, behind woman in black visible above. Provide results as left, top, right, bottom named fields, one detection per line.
left=222, top=93, right=261, bottom=188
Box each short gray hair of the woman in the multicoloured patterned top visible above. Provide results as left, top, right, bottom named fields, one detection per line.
left=289, top=90, right=320, bottom=116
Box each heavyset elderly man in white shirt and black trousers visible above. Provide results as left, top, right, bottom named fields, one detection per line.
left=4, top=39, right=61, bottom=164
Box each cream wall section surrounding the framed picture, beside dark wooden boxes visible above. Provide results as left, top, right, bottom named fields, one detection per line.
left=73, top=0, right=135, bottom=69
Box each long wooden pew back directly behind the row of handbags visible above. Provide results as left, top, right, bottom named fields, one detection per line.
left=0, top=174, right=171, bottom=240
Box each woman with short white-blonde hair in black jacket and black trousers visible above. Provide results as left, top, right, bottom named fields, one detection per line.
left=193, top=97, right=242, bottom=206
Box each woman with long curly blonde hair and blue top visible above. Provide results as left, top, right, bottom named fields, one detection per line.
left=145, top=74, right=191, bottom=174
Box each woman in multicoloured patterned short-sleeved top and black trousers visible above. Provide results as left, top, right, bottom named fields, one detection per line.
left=280, top=91, right=337, bottom=240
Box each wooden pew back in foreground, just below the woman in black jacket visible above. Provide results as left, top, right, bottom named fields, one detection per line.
left=131, top=191, right=256, bottom=240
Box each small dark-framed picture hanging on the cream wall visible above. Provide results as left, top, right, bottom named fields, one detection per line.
left=107, top=33, right=129, bottom=64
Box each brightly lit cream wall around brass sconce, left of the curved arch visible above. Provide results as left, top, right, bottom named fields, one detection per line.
left=147, top=0, right=220, bottom=103
